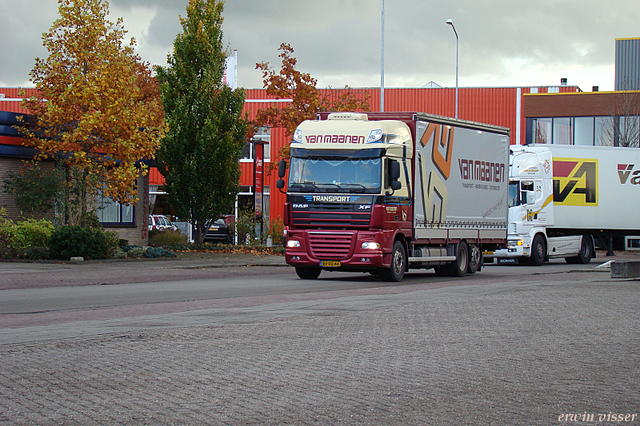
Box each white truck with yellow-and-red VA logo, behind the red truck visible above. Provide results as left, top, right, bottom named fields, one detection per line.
left=484, top=144, right=640, bottom=265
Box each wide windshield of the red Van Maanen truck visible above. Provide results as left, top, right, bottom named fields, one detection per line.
left=289, top=157, right=382, bottom=193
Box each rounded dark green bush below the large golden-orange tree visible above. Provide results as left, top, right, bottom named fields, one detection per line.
left=49, top=225, right=110, bottom=260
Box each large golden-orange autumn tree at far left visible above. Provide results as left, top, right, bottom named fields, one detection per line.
left=22, top=0, right=164, bottom=225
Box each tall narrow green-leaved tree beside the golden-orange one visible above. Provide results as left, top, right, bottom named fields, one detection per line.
left=157, top=0, right=247, bottom=243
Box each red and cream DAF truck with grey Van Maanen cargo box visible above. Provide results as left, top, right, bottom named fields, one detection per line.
left=277, top=112, right=509, bottom=281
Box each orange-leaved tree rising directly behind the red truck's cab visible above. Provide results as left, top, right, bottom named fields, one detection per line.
left=254, top=43, right=369, bottom=164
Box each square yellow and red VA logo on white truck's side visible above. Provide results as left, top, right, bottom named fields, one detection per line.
left=553, top=158, right=598, bottom=206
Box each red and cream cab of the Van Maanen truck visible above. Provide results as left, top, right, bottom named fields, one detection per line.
left=279, top=113, right=413, bottom=278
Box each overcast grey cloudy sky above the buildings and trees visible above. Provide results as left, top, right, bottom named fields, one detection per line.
left=0, top=0, right=640, bottom=91
